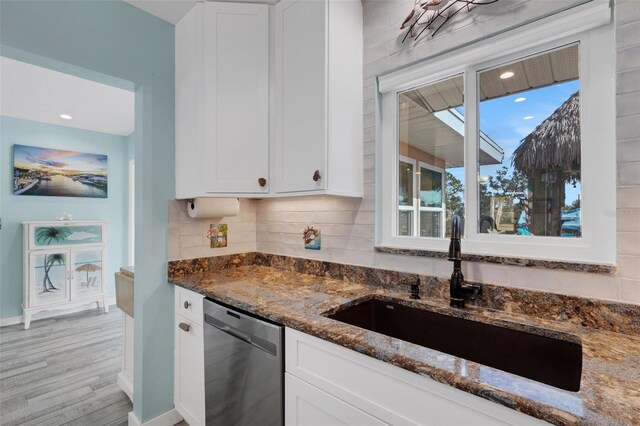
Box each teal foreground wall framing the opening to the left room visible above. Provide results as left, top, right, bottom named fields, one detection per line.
left=0, top=0, right=174, bottom=422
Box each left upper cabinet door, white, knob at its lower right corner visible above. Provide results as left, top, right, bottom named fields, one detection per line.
left=201, top=2, right=269, bottom=193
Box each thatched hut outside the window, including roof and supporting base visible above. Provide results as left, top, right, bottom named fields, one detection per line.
left=512, top=92, right=580, bottom=236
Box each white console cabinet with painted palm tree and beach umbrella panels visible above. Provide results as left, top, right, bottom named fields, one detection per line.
left=22, top=221, right=109, bottom=329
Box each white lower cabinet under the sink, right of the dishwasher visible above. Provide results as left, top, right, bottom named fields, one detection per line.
left=285, top=328, right=546, bottom=426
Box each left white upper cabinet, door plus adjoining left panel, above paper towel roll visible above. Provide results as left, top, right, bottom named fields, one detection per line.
left=176, top=2, right=269, bottom=198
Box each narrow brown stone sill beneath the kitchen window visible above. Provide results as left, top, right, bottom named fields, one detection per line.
left=375, top=246, right=616, bottom=275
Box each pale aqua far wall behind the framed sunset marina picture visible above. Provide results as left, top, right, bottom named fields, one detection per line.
left=0, top=116, right=128, bottom=318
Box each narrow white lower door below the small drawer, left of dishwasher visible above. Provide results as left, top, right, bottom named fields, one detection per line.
left=174, top=315, right=205, bottom=426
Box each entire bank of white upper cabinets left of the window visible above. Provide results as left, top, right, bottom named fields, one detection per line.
left=175, top=0, right=363, bottom=198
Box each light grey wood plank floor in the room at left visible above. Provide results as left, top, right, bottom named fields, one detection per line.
left=0, top=307, right=132, bottom=426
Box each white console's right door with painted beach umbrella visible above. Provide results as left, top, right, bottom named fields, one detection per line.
left=69, top=248, right=106, bottom=300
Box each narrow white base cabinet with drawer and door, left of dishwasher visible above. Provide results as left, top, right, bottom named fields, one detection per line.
left=173, top=287, right=205, bottom=426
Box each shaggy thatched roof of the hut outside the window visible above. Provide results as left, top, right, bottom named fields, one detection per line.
left=513, top=92, right=580, bottom=173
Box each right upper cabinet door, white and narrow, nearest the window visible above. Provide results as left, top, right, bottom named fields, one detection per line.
left=273, top=0, right=328, bottom=192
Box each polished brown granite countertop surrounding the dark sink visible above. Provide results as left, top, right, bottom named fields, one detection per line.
left=170, top=265, right=640, bottom=425
